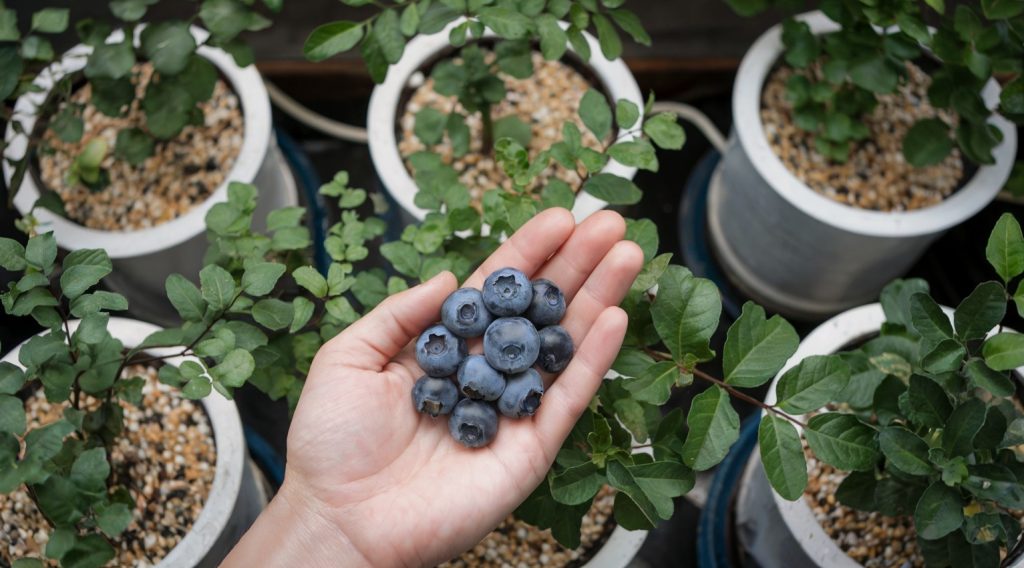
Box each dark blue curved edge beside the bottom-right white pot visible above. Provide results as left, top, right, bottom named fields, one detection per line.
left=697, top=412, right=761, bottom=568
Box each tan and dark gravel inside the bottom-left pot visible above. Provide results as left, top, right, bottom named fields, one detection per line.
left=0, top=365, right=217, bottom=567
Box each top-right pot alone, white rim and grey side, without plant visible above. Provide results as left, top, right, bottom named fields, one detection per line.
left=708, top=11, right=1017, bottom=319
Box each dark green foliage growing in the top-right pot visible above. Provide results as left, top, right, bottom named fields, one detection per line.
left=727, top=0, right=1024, bottom=167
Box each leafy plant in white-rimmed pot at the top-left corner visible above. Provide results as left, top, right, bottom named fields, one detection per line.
left=0, top=0, right=296, bottom=322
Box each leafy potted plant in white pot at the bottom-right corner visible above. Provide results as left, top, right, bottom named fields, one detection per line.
left=737, top=215, right=1024, bottom=567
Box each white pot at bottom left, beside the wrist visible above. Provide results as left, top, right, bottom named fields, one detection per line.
left=2, top=317, right=266, bottom=568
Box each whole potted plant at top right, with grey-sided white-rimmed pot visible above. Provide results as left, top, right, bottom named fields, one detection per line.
left=708, top=0, right=1024, bottom=318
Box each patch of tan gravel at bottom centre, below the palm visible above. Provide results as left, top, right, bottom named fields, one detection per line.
left=441, top=486, right=615, bottom=568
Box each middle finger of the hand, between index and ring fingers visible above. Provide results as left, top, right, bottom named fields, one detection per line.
left=535, top=211, right=626, bottom=302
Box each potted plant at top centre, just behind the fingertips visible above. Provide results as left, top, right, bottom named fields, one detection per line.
left=304, top=0, right=681, bottom=220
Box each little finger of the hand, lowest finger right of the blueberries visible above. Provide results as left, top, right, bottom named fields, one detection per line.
left=534, top=306, right=628, bottom=455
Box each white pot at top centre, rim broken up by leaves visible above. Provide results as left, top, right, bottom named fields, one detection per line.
left=367, top=20, right=644, bottom=222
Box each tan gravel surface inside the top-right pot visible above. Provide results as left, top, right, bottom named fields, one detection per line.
left=761, top=63, right=964, bottom=211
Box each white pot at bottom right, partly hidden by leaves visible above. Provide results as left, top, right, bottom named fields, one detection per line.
left=736, top=304, right=1024, bottom=568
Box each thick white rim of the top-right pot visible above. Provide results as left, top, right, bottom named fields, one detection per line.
left=732, top=10, right=1017, bottom=237
